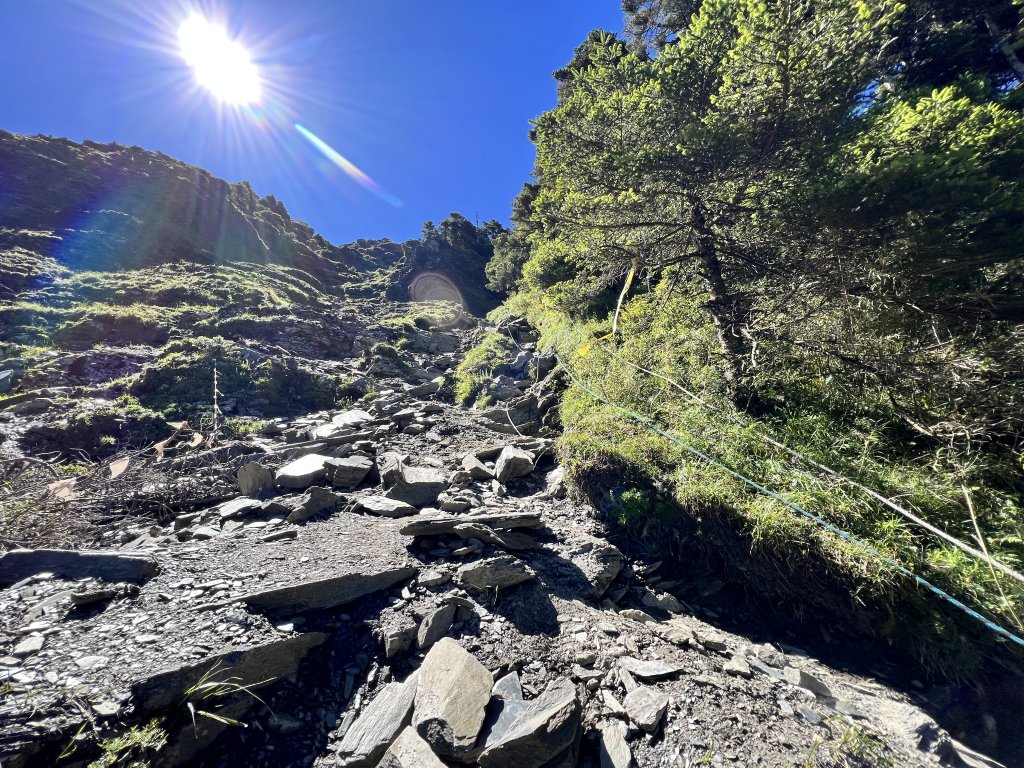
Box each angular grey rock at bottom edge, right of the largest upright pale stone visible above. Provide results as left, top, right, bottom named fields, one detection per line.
left=477, top=678, right=583, bottom=768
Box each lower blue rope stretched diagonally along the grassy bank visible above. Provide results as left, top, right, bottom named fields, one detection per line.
left=555, top=352, right=1024, bottom=647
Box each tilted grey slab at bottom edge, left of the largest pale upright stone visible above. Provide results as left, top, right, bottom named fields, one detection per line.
left=337, top=672, right=420, bottom=766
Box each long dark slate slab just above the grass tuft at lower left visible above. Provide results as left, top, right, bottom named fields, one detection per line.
left=131, top=632, right=327, bottom=713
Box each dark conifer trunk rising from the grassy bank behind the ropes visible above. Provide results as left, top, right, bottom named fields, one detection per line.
left=691, top=204, right=764, bottom=413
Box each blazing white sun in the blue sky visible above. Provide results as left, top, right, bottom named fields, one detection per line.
left=178, top=15, right=260, bottom=104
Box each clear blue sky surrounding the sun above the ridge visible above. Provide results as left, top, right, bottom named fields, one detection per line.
left=0, top=0, right=622, bottom=243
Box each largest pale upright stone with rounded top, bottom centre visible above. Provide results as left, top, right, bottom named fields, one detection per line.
left=413, top=637, right=494, bottom=758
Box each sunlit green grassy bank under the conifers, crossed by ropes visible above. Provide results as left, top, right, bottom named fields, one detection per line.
left=500, top=289, right=1024, bottom=677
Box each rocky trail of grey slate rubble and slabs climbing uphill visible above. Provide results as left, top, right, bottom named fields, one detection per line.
left=0, top=325, right=997, bottom=768
